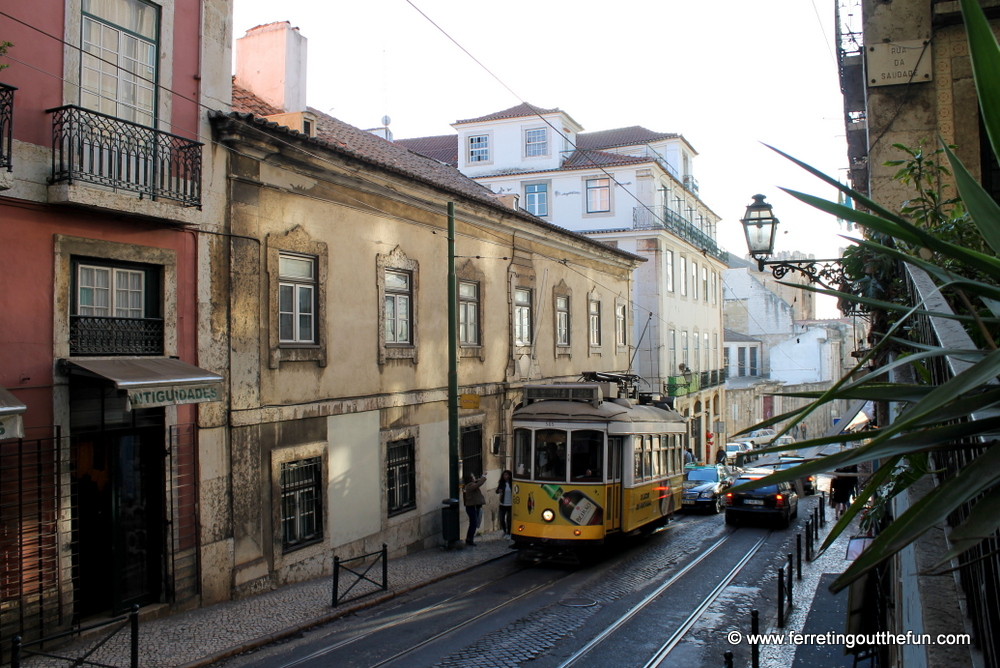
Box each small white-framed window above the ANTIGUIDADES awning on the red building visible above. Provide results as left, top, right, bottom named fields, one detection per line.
left=76, top=264, right=146, bottom=318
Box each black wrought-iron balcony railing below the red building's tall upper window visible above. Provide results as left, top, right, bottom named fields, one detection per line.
left=47, top=105, right=202, bottom=207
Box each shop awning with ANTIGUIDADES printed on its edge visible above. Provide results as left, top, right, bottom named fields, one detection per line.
left=68, top=357, right=223, bottom=408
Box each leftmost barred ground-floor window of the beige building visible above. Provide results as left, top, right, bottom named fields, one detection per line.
left=281, top=457, right=323, bottom=552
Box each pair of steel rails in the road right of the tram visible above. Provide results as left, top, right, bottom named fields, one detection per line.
left=558, top=531, right=773, bottom=668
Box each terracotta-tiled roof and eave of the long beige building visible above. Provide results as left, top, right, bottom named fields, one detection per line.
left=223, top=83, right=645, bottom=261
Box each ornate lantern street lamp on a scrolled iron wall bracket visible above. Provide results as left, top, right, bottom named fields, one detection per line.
left=740, top=195, right=851, bottom=290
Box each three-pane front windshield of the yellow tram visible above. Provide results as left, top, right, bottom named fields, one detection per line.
left=514, top=429, right=605, bottom=482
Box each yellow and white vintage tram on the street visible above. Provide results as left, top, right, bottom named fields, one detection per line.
left=511, top=382, right=687, bottom=553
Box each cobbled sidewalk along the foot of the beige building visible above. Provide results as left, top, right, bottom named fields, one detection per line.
left=15, top=531, right=514, bottom=668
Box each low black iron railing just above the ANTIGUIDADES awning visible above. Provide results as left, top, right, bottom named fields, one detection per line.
left=69, top=315, right=163, bottom=356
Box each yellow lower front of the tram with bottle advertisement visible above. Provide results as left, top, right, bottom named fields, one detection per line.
left=512, top=480, right=606, bottom=539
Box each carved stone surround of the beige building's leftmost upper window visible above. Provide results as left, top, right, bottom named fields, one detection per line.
left=265, top=225, right=329, bottom=369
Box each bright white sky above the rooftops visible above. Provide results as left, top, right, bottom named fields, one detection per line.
left=233, top=0, right=847, bottom=317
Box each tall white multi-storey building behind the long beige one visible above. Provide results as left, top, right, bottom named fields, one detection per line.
left=396, top=104, right=727, bottom=460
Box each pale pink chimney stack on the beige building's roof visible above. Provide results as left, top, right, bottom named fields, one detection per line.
left=236, top=21, right=308, bottom=112
